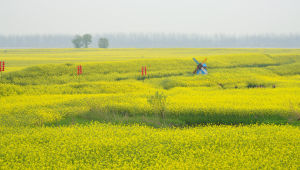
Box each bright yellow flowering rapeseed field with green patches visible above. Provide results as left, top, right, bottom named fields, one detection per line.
left=0, top=49, right=300, bottom=169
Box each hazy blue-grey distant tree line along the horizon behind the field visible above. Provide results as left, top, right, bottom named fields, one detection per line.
left=0, top=33, right=300, bottom=48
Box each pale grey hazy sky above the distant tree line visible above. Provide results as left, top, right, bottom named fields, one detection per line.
left=0, top=0, right=300, bottom=35
